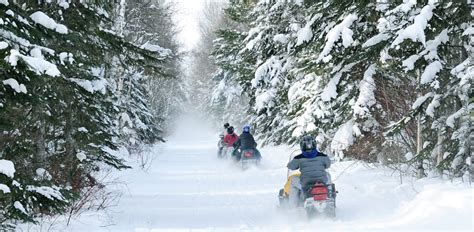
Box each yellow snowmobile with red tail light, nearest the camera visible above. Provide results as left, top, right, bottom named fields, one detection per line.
left=278, top=156, right=338, bottom=219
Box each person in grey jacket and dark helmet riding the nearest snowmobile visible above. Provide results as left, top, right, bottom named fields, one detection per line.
left=287, top=135, right=331, bottom=207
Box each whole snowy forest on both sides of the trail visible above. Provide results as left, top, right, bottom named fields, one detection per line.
left=0, top=0, right=474, bottom=230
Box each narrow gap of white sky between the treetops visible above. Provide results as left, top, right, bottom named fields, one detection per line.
left=170, top=0, right=206, bottom=51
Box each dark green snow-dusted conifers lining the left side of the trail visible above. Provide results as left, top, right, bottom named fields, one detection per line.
left=0, top=0, right=178, bottom=230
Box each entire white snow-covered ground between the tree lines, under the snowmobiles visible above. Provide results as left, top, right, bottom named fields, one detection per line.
left=58, top=116, right=474, bottom=232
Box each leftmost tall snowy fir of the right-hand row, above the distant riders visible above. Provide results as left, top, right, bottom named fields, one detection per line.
left=210, top=0, right=254, bottom=127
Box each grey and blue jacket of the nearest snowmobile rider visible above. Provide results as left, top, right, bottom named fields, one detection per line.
left=287, top=150, right=331, bottom=191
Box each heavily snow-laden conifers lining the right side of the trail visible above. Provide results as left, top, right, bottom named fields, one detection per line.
left=214, top=0, right=473, bottom=176
